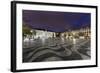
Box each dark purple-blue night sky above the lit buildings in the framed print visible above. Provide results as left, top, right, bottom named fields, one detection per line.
left=23, top=10, right=91, bottom=32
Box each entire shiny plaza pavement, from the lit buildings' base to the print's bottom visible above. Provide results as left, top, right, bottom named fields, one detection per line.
left=23, top=38, right=91, bottom=62
